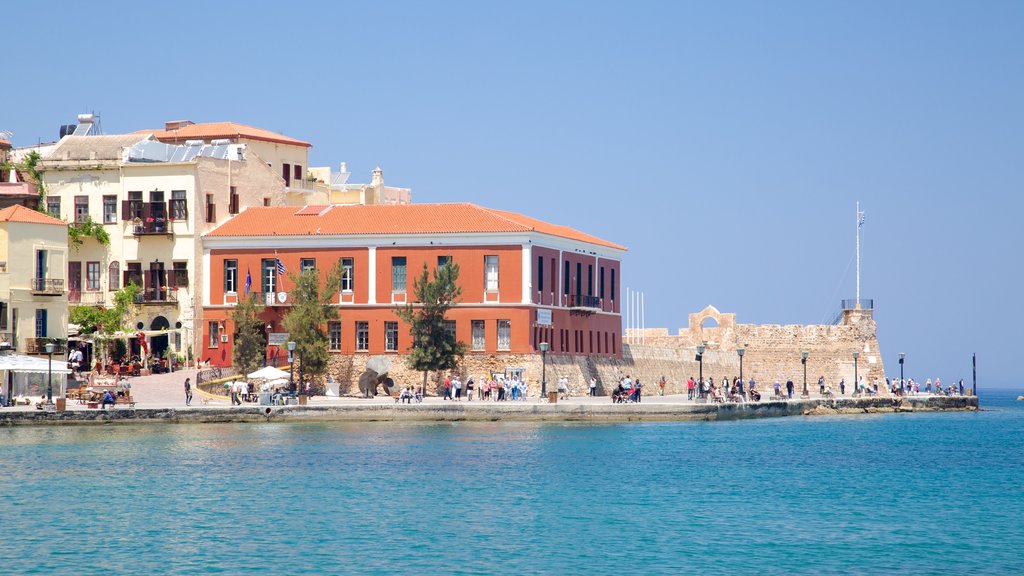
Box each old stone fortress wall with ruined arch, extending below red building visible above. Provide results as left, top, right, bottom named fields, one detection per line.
left=299, top=306, right=885, bottom=396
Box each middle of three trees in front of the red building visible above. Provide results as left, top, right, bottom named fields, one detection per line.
left=284, top=262, right=341, bottom=389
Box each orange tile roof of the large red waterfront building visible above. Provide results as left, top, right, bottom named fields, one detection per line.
left=207, top=203, right=626, bottom=250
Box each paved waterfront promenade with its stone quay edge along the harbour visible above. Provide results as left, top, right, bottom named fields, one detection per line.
left=0, top=371, right=978, bottom=425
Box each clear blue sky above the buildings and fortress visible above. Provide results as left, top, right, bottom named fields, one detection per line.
left=0, top=0, right=1024, bottom=388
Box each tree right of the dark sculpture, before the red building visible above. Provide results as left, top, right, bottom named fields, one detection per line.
left=395, top=262, right=466, bottom=392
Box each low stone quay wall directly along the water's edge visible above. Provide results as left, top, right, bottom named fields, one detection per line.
left=0, top=397, right=979, bottom=426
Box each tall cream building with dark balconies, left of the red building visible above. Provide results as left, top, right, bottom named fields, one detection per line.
left=40, top=133, right=288, bottom=355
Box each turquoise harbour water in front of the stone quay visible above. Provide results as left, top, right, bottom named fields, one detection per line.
left=0, top=393, right=1024, bottom=574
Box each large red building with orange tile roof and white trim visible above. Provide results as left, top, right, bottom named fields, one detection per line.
left=200, top=204, right=626, bottom=366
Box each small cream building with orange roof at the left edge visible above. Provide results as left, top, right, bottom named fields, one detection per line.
left=0, top=201, right=68, bottom=355
